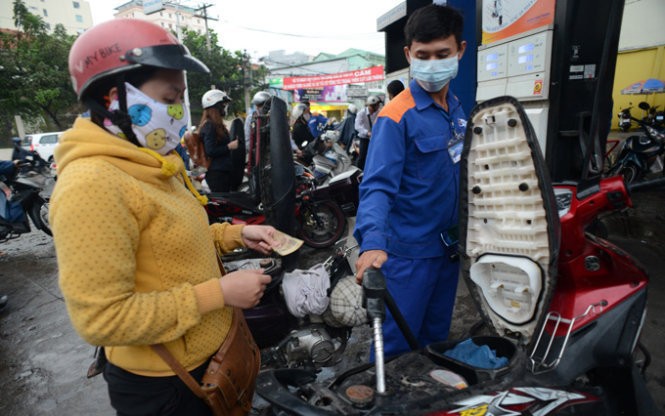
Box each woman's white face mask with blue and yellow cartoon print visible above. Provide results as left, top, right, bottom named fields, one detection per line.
left=104, top=83, right=189, bottom=155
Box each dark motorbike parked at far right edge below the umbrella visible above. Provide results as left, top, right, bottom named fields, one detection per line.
left=607, top=113, right=665, bottom=184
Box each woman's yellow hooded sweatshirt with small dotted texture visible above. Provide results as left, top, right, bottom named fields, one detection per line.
left=50, top=118, right=243, bottom=376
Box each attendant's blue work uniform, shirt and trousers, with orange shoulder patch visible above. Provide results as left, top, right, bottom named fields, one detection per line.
left=354, top=81, right=466, bottom=356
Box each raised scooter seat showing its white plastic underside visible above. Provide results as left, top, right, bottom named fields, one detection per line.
left=460, top=97, right=560, bottom=345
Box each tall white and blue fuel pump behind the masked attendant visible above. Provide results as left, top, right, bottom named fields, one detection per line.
left=377, top=0, right=624, bottom=188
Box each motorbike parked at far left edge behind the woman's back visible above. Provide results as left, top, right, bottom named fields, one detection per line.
left=0, top=152, right=55, bottom=242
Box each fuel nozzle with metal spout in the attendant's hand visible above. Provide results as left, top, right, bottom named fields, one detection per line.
left=363, top=268, right=388, bottom=394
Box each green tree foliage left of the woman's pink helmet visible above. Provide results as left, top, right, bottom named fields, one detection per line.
left=0, top=0, right=76, bottom=140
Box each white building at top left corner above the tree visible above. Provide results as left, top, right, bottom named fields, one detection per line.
left=0, top=0, right=92, bottom=35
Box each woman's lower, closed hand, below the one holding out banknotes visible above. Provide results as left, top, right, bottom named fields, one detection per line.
left=219, top=269, right=272, bottom=309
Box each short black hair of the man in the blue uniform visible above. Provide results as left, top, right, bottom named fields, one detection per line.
left=404, top=4, right=464, bottom=47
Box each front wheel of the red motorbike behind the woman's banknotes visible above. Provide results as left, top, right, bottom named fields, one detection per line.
left=299, top=201, right=346, bottom=248
